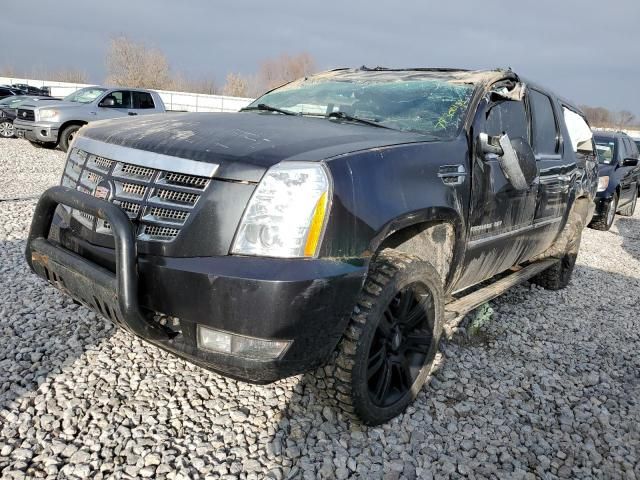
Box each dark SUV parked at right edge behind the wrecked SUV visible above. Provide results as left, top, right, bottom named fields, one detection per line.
left=589, top=131, right=640, bottom=230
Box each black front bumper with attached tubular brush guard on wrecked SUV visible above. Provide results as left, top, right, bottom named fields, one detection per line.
left=26, top=187, right=366, bottom=383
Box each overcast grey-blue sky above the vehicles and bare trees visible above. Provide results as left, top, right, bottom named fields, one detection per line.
left=0, top=0, right=640, bottom=117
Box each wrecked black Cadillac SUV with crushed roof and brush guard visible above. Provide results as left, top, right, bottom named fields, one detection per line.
left=26, top=67, right=597, bottom=424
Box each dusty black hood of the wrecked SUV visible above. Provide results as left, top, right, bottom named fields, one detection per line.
left=81, top=112, right=430, bottom=181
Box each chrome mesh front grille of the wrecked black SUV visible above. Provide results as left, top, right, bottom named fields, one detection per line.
left=61, top=148, right=210, bottom=242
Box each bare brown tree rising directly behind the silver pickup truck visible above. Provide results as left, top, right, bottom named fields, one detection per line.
left=107, top=36, right=172, bottom=89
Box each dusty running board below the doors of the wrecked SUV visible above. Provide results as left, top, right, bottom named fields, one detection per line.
left=444, top=258, right=558, bottom=327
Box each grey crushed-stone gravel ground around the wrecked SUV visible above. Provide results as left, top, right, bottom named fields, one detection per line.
left=0, top=140, right=640, bottom=479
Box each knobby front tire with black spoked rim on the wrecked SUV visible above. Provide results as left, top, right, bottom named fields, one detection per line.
left=330, top=249, right=444, bottom=425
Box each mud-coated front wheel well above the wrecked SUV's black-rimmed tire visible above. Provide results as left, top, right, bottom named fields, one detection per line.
left=377, top=222, right=456, bottom=285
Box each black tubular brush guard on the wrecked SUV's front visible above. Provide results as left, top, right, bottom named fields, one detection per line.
left=26, top=187, right=172, bottom=341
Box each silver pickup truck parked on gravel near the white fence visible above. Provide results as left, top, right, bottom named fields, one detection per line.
left=13, top=87, right=166, bottom=152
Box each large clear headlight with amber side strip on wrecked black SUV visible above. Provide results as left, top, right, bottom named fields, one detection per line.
left=231, top=162, right=331, bottom=258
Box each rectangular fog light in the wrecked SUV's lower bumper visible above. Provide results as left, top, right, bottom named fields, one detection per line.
left=198, top=325, right=291, bottom=360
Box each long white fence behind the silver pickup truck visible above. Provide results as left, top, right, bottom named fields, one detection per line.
left=0, top=77, right=253, bottom=112
